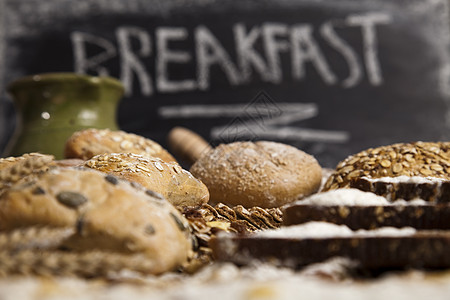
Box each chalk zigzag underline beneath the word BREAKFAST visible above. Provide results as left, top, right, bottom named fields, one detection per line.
left=158, top=103, right=350, bottom=143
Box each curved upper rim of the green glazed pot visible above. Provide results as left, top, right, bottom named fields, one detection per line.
left=7, top=72, right=124, bottom=93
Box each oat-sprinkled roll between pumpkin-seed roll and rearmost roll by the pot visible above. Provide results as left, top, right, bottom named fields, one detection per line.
left=85, top=153, right=209, bottom=206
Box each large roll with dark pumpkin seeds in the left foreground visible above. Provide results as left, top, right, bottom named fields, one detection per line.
left=0, top=168, right=192, bottom=274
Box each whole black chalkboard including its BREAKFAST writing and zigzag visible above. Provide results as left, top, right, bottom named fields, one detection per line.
left=0, top=0, right=450, bottom=167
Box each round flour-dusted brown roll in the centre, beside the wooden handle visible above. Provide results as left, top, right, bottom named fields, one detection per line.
left=190, top=141, right=322, bottom=208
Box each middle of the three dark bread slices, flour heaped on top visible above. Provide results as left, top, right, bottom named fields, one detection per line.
left=282, top=188, right=450, bottom=229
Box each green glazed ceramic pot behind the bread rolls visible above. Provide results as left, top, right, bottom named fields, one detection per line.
left=4, top=73, right=124, bottom=159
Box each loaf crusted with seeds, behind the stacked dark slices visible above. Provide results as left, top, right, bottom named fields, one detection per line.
left=323, top=142, right=450, bottom=191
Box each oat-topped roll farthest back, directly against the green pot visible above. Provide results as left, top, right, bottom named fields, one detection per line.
left=64, top=128, right=177, bottom=162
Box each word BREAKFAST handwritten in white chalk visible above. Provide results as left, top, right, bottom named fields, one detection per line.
left=71, top=12, right=392, bottom=96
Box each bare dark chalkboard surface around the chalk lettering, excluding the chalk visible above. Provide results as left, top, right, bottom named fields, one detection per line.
left=0, top=0, right=450, bottom=167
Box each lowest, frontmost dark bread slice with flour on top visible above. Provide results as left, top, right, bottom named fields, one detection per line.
left=210, top=222, right=450, bottom=270
